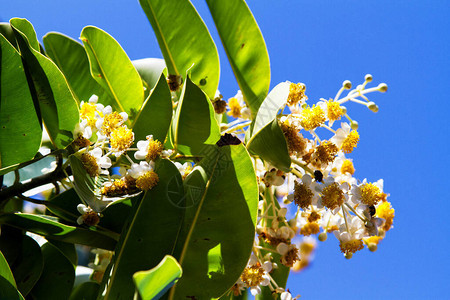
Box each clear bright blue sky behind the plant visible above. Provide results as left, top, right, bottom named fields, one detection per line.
left=0, top=0, right=450, bottom=299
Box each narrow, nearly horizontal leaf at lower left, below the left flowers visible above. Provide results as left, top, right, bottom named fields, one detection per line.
left=0, top=213, right=116, bottom=250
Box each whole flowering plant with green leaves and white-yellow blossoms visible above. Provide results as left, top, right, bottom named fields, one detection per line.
left=0, top=0, right=394, bottom=299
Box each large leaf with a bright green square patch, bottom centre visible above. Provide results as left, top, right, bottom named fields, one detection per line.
left=170, top=144, right=258, bottom=299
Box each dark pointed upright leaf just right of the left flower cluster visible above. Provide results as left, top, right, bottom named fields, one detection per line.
left=132, top=73, right=172, bottom=143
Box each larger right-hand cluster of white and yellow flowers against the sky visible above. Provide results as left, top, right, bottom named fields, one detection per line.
left=228, top=75, right=394, bottom=299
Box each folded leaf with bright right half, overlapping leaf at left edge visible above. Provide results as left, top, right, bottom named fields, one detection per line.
left=10, top=18, right=79, bottom=148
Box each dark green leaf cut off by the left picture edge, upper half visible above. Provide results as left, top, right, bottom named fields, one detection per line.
left=0, top=35, right=42, bottom=170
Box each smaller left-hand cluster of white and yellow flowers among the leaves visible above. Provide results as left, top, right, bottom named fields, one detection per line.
left=73, top=95, right=171, bottom=226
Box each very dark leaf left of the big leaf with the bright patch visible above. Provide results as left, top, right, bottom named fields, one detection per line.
left=102, top=160, right=184, bottom=299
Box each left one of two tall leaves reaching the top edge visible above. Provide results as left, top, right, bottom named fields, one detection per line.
left=139, top=0, right=220, bottom=99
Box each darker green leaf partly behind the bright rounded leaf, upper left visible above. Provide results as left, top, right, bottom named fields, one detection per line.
left=43, top=32, right=114, bottom=106
